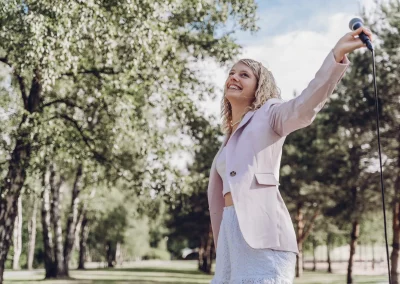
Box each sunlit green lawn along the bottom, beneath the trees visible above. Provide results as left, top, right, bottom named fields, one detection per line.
left=4, top=261, right=388, bottom=284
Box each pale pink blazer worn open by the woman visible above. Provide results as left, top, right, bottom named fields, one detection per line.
left=207, top=51, right=350, bottom=253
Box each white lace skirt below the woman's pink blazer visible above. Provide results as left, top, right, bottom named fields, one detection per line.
left=211, top=206, right=296, bottom=284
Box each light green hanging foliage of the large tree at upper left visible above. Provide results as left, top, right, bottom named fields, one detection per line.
left=0, top=0, right=257, bottom=193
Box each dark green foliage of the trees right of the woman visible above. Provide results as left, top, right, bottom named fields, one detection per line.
left=281, top=1, right=400, bottom=258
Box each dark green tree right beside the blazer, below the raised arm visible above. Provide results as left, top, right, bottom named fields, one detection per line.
left=280, top=110, right=342, bottom=277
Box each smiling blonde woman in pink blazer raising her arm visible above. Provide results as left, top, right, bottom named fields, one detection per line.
left=207, top=27, right=372, bottom=284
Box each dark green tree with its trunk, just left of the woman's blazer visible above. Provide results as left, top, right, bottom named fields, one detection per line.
left=167, top=117, right=221, bottom=273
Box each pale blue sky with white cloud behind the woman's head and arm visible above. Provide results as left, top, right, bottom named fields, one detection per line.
left=201, top=0, right=373, bottom=121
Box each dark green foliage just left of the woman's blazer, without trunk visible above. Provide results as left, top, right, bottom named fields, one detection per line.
left=167, top=118, right=220, bottom=258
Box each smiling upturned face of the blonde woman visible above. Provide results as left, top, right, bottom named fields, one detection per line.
left=224, top=62, right=257, bottom=105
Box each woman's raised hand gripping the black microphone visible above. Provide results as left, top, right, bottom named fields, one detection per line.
left=333, top=27, right=372, bottom=62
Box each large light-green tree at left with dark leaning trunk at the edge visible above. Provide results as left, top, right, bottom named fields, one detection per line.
left=0, top=0, right=256, bottom=283
